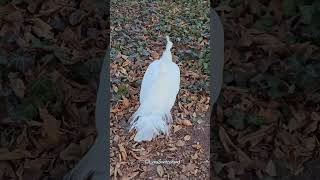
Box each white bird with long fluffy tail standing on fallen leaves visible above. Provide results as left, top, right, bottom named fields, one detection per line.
left=130, top=36, right=180, bottom=142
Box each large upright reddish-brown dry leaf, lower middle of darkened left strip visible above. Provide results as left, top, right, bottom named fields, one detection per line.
left=39, top=108, right=61, bottom=143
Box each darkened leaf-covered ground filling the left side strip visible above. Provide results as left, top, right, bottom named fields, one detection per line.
left=0, top=0, right=109, bottom=180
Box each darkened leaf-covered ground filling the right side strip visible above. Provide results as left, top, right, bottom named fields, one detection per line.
left=211, top=0, right=320, bottom=180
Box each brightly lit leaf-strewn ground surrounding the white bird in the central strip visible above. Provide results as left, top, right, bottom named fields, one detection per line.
left=110, top=1, right=210, bottom=179
